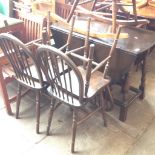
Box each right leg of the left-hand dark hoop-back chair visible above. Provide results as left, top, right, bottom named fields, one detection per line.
left=36, top=91, right=40, bottom=134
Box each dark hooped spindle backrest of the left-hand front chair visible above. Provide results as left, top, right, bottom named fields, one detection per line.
left=0, top=33, right=42, bottom=89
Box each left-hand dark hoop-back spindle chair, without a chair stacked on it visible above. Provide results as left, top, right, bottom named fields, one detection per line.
left=0, top=33, right=45, bottom=133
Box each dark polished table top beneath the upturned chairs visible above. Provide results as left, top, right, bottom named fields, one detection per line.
left=51, top=18, right=155, bottom=59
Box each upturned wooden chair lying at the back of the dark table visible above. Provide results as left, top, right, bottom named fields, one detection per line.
left=67, top=0, right=149, bottom=33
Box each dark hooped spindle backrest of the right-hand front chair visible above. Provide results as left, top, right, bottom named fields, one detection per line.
left=37, top=45, right=84, bottom=104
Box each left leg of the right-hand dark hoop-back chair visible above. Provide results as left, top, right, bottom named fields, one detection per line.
left=46, top=99, right=56, bottom=135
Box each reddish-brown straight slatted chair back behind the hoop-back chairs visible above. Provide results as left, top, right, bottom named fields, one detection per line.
left=18, top=12, right=47, bottom=43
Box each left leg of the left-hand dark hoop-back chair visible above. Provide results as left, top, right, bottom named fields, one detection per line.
left=16, top=83, right=22, bottom=119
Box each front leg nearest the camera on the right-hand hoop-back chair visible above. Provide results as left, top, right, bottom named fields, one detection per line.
left=71, top=108, right=77, bottom=153
